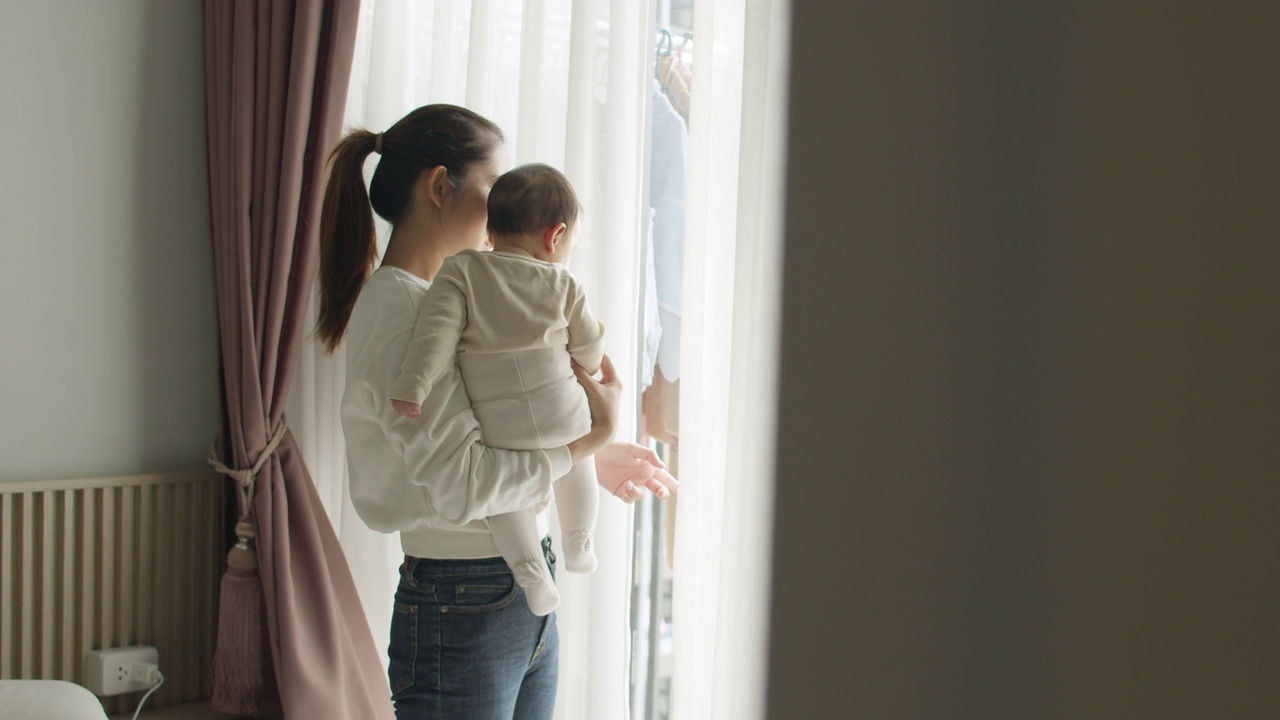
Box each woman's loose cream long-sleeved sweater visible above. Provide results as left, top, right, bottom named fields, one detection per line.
left=342, top=268, right=572, bottom=559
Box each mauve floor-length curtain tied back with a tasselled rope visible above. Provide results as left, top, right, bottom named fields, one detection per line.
left=205, top=0, right=392, bottom=719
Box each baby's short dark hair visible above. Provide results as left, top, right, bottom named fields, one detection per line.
left=489, top=163, right=581, bottom=234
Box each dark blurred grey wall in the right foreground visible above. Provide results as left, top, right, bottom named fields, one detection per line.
left=769, top=0, right=1280, bottom=720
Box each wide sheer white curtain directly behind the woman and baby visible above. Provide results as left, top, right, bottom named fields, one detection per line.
left=289, top=0, right=652, bottom=717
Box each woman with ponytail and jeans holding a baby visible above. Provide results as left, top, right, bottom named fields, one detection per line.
left=317, top=105, right=669, bottom=720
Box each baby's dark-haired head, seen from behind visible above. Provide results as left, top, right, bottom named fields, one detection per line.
left=489, top=163, right=582, bottom=263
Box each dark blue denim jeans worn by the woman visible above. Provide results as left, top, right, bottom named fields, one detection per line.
left=388, top=537, right=559, bottom=720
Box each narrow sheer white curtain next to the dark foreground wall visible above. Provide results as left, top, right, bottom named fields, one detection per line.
left=672, top=0, right=790, bottom=720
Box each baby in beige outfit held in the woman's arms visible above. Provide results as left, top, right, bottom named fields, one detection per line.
left=390, top=164, right=604, bottom=615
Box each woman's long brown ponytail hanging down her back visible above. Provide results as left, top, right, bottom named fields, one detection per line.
left=316, top=129, right=378, bottom=352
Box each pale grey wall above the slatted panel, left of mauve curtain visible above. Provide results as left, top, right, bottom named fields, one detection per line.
left=0, top=0, right=218, bottom=480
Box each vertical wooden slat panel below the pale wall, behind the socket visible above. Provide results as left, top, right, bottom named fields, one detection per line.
left=0, top=473, right=224, bottom=714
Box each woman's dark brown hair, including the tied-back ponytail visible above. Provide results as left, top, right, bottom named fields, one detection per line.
left=316, top=105, right=503, bottom=352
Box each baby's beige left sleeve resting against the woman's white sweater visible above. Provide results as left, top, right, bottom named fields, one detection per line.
left=390, top=260, right=467, bottom=405
